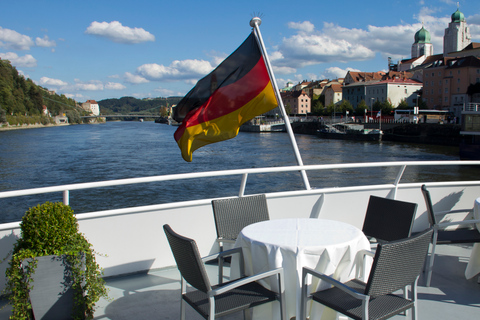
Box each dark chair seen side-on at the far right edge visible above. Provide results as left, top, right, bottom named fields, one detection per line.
left=422, top=185, right=480, bottom=287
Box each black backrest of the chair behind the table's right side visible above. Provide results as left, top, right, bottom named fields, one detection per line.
left=362, top=196, right=417, bottom=241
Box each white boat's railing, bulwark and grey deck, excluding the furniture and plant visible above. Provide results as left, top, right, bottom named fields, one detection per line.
left=0, top=161, right=480, bottom=319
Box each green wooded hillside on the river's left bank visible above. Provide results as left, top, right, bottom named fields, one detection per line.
left=0, top=59, right=80, bottom=124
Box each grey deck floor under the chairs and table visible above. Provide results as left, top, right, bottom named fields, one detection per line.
left=0, top=245, right=480, bottom=320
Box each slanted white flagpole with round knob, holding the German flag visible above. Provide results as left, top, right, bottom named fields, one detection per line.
left=250, top=17, right=311, bottom=190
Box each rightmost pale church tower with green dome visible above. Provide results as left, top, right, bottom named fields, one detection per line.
left=443, top=8, right=472, bottom=55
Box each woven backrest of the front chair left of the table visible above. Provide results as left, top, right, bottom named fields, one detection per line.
left=163, top=224, right=211, bottom=293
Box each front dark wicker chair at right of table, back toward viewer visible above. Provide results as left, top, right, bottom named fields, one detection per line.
left=300, top=229, right=433, bottom=320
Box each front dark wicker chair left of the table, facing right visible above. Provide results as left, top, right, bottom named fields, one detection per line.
left=163, top=225, right=286, bottom=320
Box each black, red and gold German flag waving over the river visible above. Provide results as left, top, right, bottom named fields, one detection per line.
left=173, top=32, right=278, bottom=162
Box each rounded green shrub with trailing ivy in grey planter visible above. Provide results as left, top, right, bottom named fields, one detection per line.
left=5, top=202, right=107, bottom=319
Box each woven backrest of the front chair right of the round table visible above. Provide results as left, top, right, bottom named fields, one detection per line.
left=365, top=228, right=433, bottom=297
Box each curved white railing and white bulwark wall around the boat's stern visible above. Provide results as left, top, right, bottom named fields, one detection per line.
left=0, top=161, right=480, bottom=289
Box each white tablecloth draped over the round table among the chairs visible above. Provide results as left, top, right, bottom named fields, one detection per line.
left=235, top=219, right=370, bottom=320
